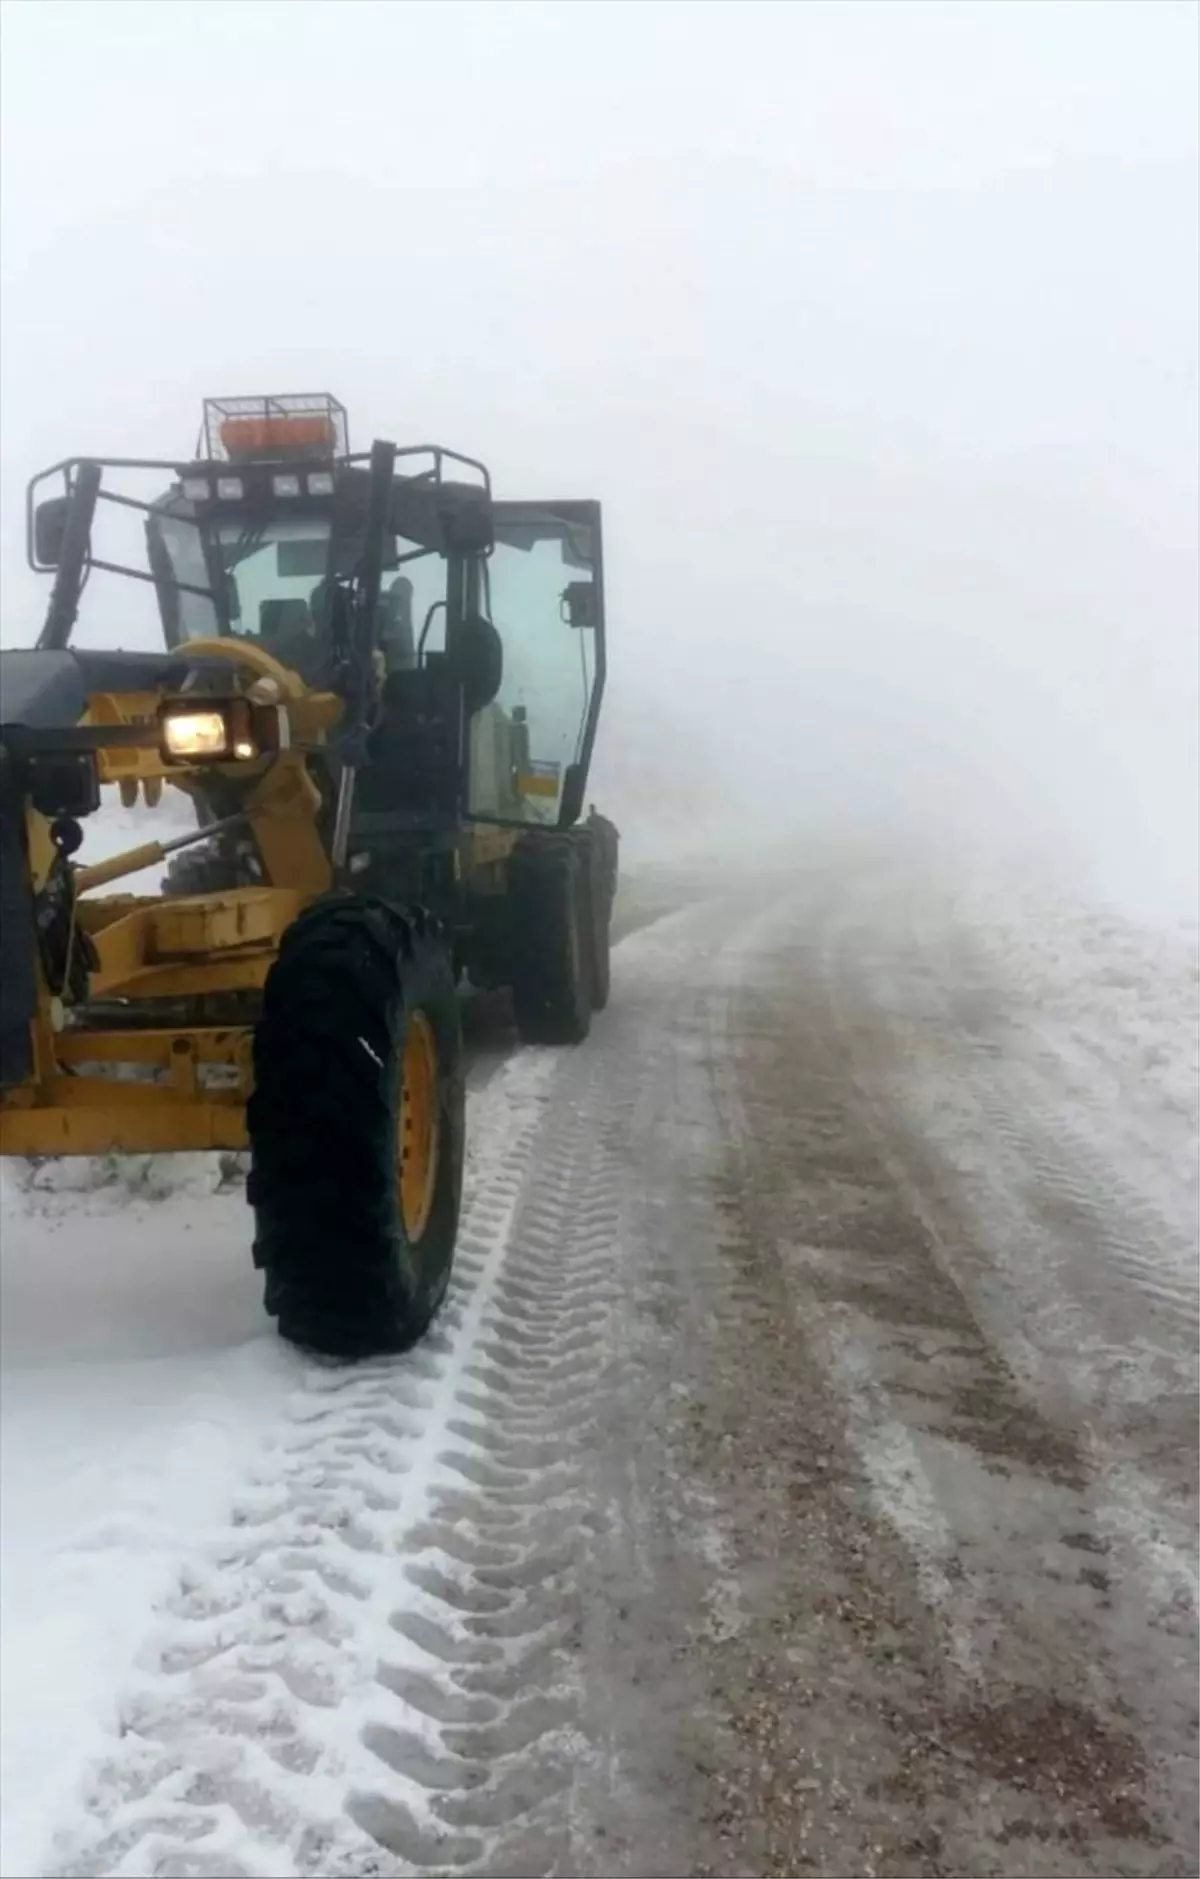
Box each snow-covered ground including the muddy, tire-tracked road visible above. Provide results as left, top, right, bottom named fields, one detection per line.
left=0, top=857, right=1200, bottom=1875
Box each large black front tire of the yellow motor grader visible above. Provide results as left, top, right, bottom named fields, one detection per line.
left=246, top=894, right=466, bottom=1357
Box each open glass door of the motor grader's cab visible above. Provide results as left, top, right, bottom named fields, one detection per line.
left=468, top=502, right=605, bottom=827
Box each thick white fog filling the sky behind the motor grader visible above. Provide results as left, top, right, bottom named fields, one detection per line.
left=0, top=0, right=1200, bottom=917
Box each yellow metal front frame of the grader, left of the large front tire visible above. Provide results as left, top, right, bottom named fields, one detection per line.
left=0, top=641, right=342, bottom=1156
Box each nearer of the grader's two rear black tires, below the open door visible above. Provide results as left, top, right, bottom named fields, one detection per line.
left=509, top=834, right=592, bottom=1045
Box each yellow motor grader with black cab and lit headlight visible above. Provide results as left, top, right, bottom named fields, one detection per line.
left=0, top=395, right=618, bottom=1357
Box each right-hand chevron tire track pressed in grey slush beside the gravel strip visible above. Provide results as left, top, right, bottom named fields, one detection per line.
left=351, top=1058, right=630, bottom=1873
